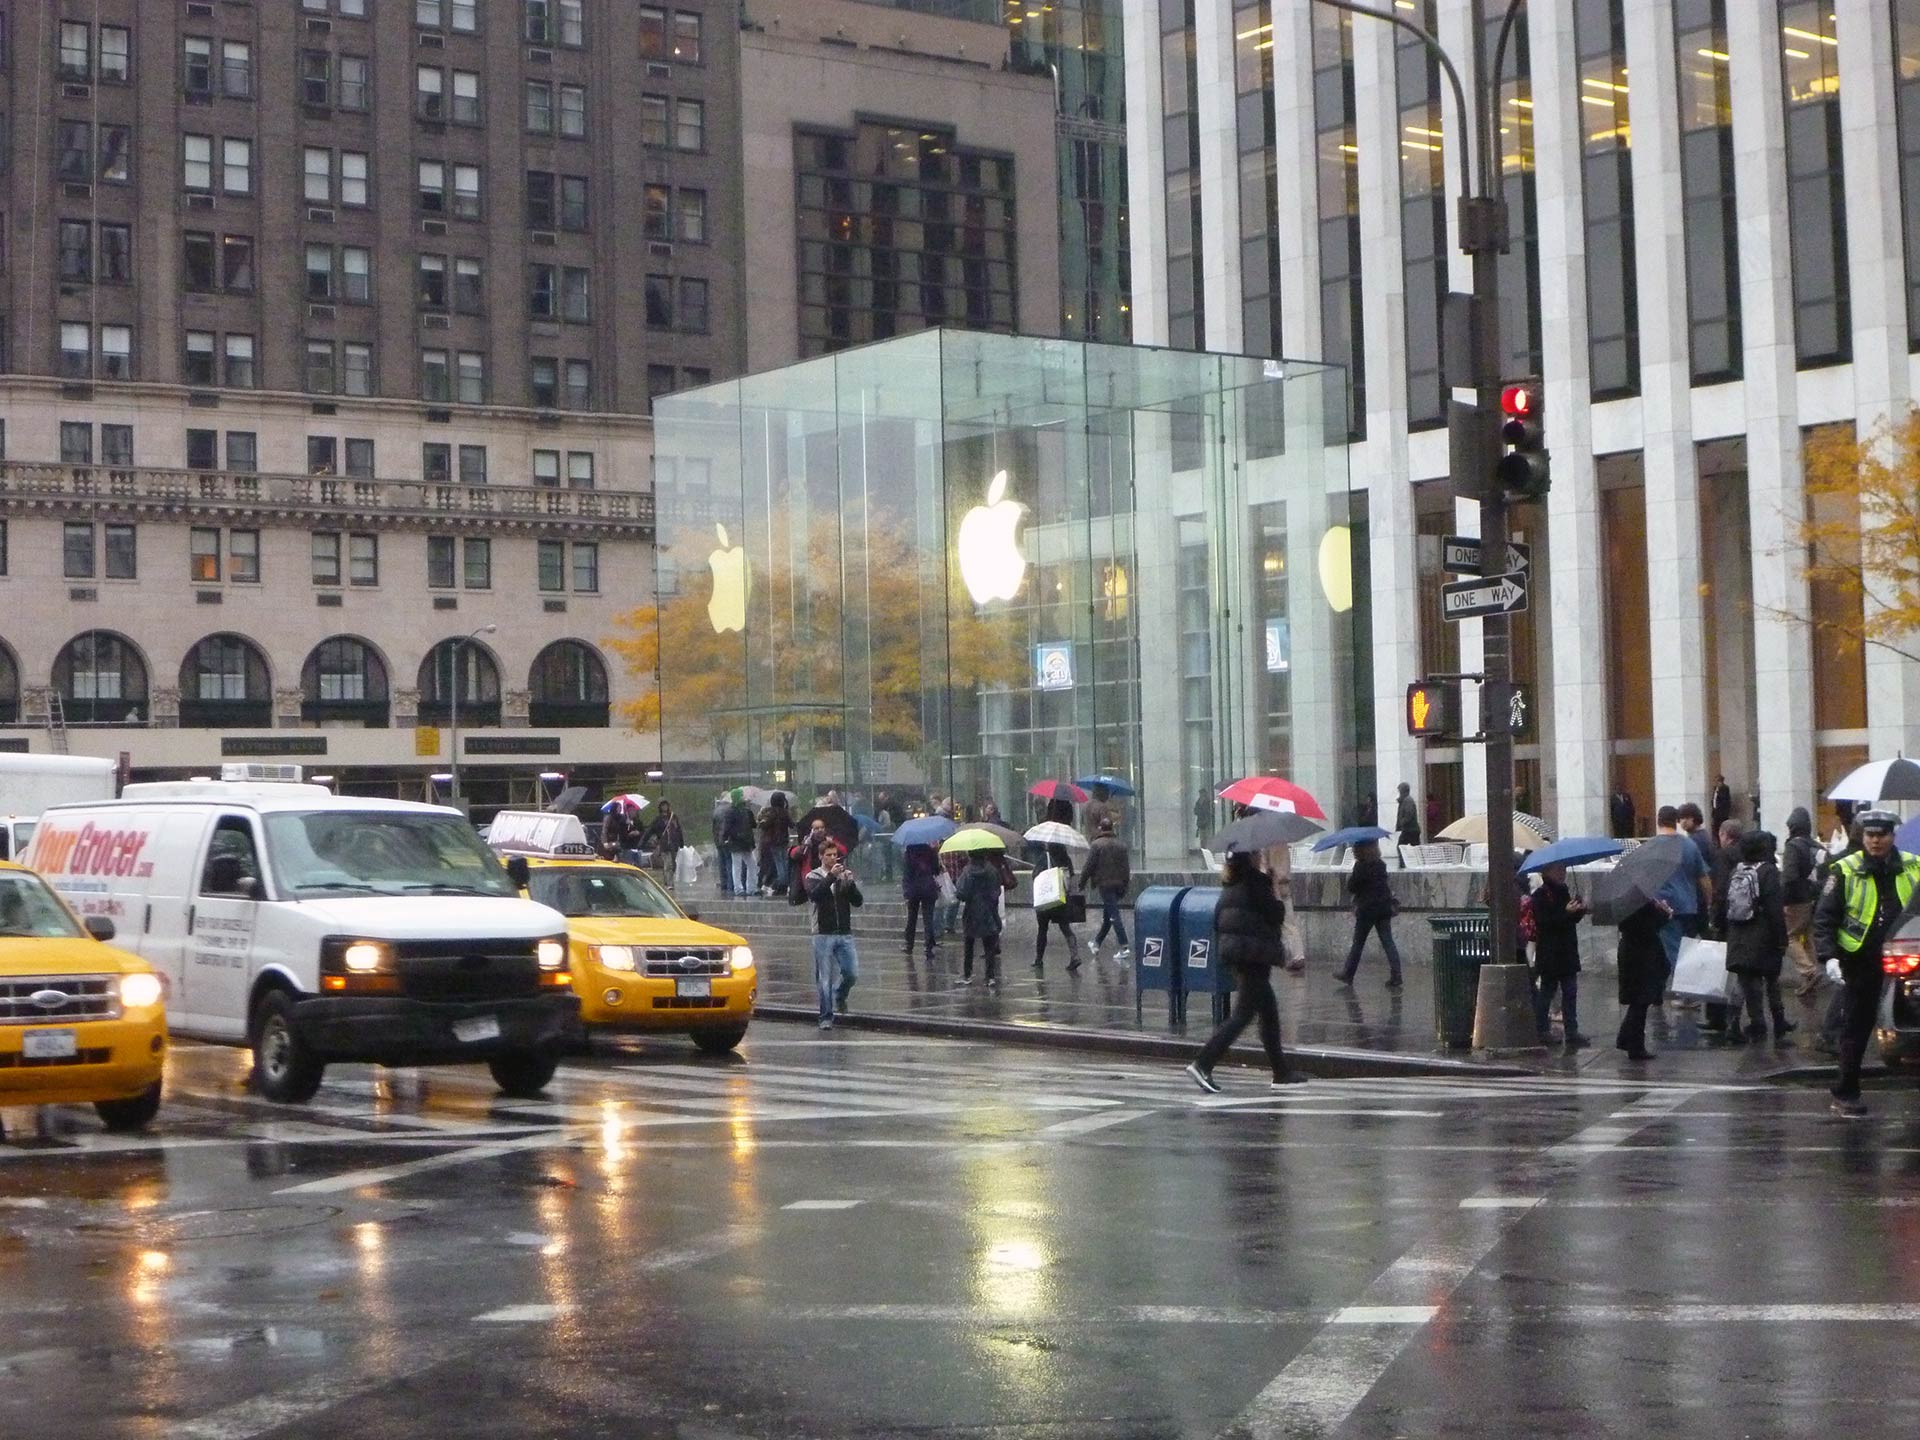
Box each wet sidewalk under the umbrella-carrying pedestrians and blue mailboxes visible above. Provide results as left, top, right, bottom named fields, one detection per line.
left=691, top=895, right=1832, bottom=1083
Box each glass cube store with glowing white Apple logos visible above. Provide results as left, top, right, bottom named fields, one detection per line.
left=655, top=330, right=1373, bottom=870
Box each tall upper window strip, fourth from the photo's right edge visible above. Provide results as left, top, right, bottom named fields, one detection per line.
left=1574, top=0, right=1640, bottom=399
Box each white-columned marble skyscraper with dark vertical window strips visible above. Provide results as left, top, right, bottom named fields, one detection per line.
left=1125, top=0, right=1920, bottom=833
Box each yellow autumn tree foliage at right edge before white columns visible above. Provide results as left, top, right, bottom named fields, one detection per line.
left=1793, top=409, right=1920, bottom=660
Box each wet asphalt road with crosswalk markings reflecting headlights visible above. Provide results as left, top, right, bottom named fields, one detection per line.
left=0, top=1021, right=1920, bottom=1440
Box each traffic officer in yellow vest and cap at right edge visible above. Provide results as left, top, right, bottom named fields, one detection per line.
left=1812, top=810, right=1920, bottom=1117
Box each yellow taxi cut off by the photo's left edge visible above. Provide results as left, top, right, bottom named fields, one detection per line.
left=0, top=862, right=167, bottom=1131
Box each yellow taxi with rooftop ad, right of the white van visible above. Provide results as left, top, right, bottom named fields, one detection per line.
left=490, top=816, right=760, bottom=1054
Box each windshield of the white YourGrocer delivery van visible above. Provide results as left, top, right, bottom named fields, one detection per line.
left=265, top=810, right=515, bottom=899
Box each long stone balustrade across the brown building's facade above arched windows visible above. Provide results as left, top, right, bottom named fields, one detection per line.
left=0, top=461, right=653, bottom=534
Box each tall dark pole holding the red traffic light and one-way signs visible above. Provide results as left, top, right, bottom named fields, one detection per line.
left=1317, top=0, right=1526, bottom=964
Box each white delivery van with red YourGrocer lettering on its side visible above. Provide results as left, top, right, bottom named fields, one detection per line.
left=27, top=780, right=580, bottom=1104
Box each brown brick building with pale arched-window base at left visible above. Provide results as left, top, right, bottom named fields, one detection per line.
left=0, top=0, right=743, bottom=799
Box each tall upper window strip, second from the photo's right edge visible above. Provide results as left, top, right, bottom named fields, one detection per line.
left=1780, top=0, right=1853, bottom=365
